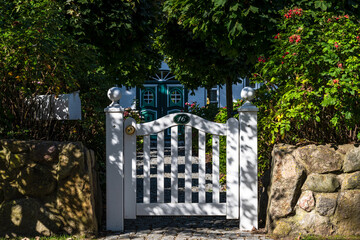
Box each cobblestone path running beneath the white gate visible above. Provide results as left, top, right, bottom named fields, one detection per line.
left=102, top=217, right=270, bottom=240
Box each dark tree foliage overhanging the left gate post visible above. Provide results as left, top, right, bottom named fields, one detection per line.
left=63, top=0, right=161, bottom=86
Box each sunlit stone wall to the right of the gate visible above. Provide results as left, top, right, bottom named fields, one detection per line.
left=266, top=144, right=360, bottom=236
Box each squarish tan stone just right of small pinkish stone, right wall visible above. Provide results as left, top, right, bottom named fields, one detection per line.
left=315, top=193, right=338, bottom=216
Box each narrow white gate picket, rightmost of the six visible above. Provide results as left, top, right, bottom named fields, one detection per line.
left=212, top=135, right=220, bottom=203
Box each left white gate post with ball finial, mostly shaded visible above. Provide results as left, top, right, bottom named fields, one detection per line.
left=104, top=87, right=124, bottom=231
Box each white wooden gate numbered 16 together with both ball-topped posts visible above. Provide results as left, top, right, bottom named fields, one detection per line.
left=105, top=88, right=257, bottom=231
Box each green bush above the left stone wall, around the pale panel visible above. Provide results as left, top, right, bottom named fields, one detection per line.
left=0, top=0, right=109, bottom=168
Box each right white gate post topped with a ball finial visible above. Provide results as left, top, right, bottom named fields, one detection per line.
left=238, top=87, right=259, bottom=231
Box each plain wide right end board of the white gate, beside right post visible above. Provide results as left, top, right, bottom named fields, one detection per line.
left=226, top=118, right=239, bottom=219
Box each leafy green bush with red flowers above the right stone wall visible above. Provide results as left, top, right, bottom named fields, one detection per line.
left=252, top=8, right=360, bottom=144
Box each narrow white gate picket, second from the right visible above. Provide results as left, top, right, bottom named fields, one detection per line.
left=199, top=130, right=206, bottom=203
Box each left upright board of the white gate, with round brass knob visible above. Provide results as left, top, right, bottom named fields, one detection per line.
left=124, top=118, right=136, bottom=219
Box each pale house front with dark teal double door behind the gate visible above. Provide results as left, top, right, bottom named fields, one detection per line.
left=120, top=62, right=259, bottom=122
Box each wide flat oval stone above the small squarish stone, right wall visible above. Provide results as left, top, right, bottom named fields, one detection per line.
left=303, top=173, right=340, bottom=192
